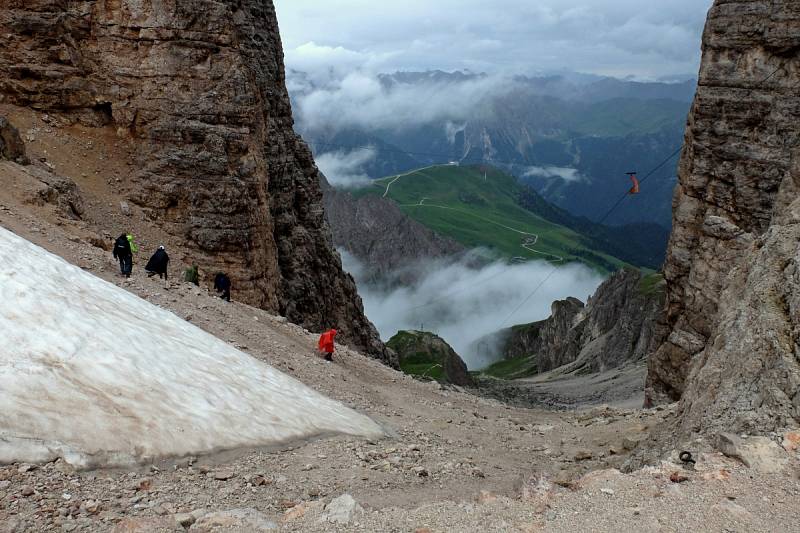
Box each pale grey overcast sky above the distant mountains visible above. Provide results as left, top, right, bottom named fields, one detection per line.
left=275, top=0, right=712, bottom=79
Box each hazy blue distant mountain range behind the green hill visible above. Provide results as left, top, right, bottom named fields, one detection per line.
left=293, top=71, right=696, bottom=230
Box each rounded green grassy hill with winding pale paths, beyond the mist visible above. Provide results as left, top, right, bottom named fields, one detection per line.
left=356, top=166, right=625, bottom=272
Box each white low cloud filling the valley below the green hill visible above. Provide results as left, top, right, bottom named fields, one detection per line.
left=340, top=250, right=603, bottom=370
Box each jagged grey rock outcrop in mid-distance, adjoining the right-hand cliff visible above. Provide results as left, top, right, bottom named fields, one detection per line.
left=494, top=270, right=664, bottom=373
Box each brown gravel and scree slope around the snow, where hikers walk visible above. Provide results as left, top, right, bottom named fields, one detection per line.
left=0, top=103, right=800, bottom=533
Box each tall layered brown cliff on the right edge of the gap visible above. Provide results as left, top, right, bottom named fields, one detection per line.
left=647, top=0, right=800, bottom=434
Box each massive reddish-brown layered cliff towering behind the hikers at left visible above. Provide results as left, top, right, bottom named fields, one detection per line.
left=0, top=0, right=385, bottom=357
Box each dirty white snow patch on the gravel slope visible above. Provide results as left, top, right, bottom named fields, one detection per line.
left=0, top=228, right=384, bottom=468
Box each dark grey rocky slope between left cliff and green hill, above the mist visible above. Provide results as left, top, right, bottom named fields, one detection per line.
left=323, top=179, right=464, bottom=284
